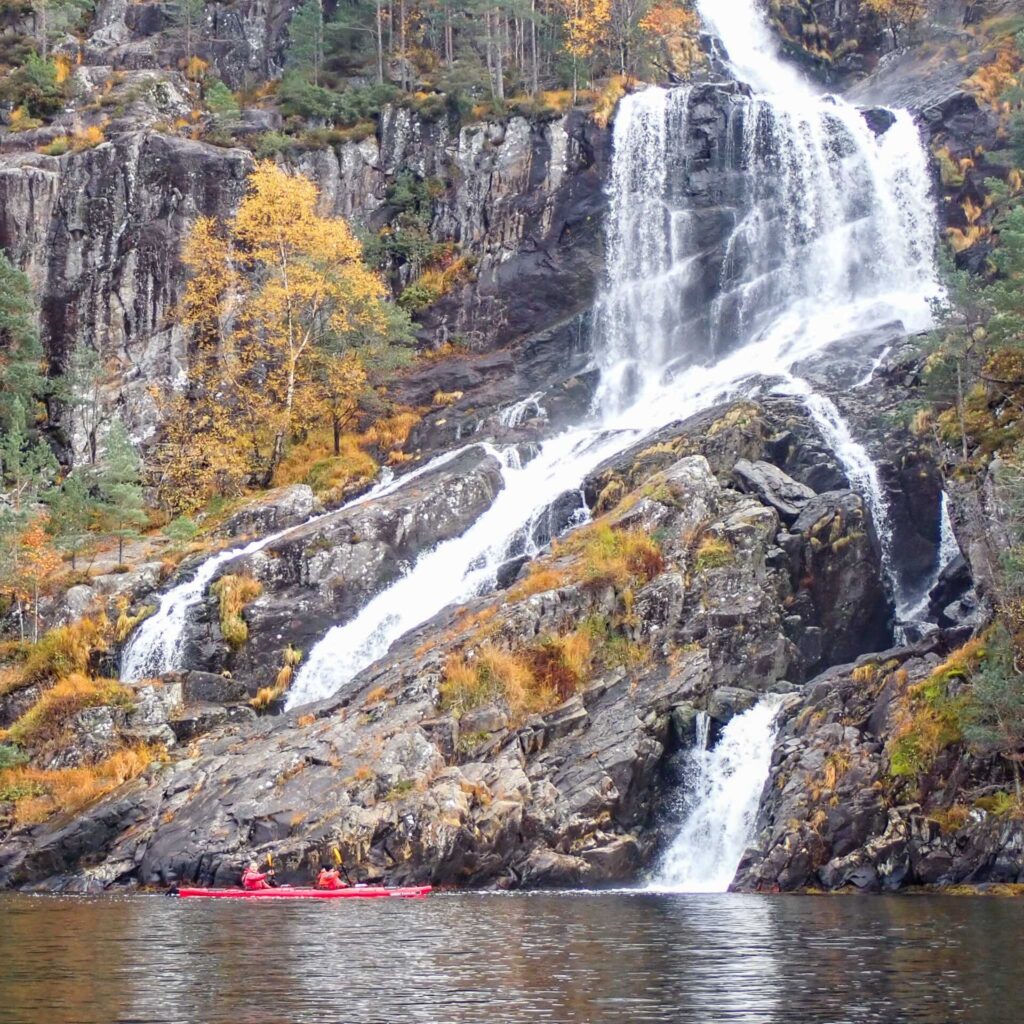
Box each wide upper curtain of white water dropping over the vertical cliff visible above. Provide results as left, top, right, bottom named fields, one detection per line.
left=595, top=78, right=938, bottom=413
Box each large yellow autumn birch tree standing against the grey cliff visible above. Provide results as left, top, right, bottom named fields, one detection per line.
left=165, top=161, right=389, bottom=507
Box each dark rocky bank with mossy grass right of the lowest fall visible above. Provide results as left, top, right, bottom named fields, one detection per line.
left=735, top=639, right=1024, bottom=891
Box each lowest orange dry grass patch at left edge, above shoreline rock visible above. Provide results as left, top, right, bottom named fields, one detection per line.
left=0, top=745, right=157, bottom=825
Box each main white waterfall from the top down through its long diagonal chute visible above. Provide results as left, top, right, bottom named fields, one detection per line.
left=117, top=0, right=937, bottom=707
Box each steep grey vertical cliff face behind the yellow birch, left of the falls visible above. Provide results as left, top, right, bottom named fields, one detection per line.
left=0, top=106, right=608, bottom=457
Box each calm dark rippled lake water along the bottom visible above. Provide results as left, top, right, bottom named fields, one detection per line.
left=0, top=894, right=1024, bottom=1024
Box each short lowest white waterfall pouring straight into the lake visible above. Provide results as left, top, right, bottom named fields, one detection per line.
left=649, top=697, right=778, bottom=893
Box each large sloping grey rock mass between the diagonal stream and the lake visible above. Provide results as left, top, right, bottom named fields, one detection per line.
left=0, top=391, right=909, bottom=888
